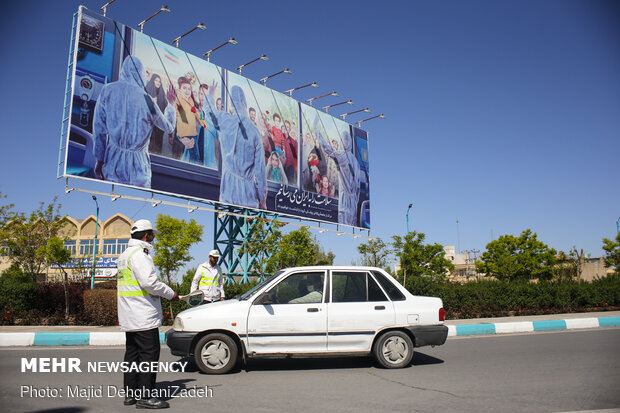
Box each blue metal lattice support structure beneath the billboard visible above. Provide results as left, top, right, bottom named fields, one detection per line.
left=213, top=205, right=279, bottom=284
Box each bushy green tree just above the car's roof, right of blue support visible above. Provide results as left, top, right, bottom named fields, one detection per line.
left=267, top=227, right=317, bottom=273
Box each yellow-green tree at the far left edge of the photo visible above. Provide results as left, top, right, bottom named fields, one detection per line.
left=0, top=198, right=64, bottom=281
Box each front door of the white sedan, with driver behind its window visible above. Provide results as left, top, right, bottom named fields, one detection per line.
left=247, top=271, right=327, bottom=354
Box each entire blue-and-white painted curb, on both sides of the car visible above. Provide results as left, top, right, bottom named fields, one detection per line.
left=0, top=317, right=620, bottom=347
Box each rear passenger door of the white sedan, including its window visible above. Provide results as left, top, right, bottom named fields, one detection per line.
left=327, top=271, right=395, bottom=352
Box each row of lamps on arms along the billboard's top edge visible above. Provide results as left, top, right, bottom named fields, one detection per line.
left=101, top=0, right=385, bottom=127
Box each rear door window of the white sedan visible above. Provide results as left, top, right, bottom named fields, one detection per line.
left=332, top=271, right=388, bottom=303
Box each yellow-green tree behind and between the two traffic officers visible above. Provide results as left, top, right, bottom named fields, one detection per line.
left=153, top=214, right=203, bottom=318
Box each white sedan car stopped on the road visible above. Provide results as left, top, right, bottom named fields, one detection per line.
left=166, top=266, right=448, bottom=374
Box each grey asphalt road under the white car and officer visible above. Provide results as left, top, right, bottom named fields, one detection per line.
left=0, top=328, right=620, bottom=413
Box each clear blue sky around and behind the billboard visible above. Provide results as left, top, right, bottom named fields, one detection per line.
left=0, top=0, right=620, bottom=276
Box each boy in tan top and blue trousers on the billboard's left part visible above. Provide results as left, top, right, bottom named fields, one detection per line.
left=176, top=76, right=208, bottom=164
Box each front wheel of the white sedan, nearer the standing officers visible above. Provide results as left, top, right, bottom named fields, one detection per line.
left=194, top=333, right=239, bottom=374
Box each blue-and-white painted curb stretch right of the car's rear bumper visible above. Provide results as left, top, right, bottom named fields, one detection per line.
left=448, top=317, right=620, bottom=337
